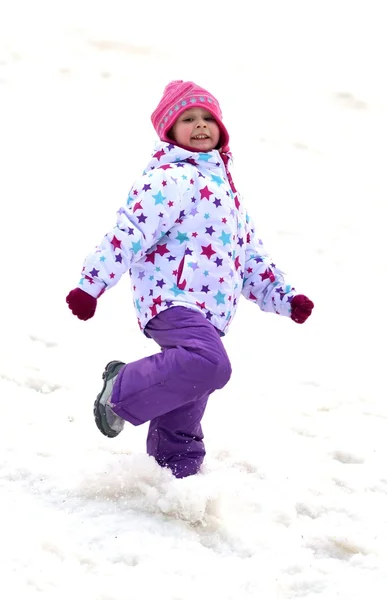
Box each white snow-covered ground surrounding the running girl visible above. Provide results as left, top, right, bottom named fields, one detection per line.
left=0, top=0, right=387, bottom=600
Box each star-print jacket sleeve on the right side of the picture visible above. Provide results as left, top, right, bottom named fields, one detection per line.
left=242, top=210, right=296, bottom=316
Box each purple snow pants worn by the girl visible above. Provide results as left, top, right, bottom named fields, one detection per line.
left=112, top=306, right=231, bottom=478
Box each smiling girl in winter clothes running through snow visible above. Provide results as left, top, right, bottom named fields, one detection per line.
left=66, top=81, right=313, bottom=477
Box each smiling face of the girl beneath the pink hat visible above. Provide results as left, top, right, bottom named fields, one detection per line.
left=169, top=106, right=220, bottom=152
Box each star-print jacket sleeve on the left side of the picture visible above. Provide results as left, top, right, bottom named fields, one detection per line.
left=78, top=169, right=181, bottom=298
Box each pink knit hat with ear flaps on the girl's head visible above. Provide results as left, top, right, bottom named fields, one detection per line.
left=151, top=80, right=229, bottom=152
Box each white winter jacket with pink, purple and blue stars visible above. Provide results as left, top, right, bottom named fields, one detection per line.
left=79, top=142, right=296, bottom=333
